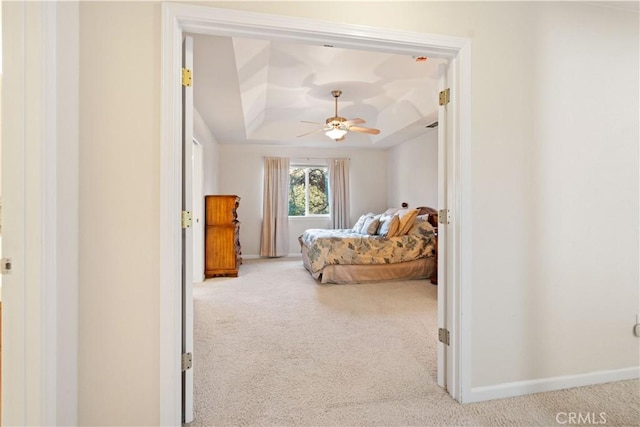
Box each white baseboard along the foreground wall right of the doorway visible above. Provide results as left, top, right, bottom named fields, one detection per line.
left=461, top=366, right=640, bottom=403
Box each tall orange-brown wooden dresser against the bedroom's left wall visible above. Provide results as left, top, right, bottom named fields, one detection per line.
left=204, top=195, right=242, bottom=277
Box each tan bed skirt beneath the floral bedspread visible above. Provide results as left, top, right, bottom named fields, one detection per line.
left=302, top=245, right=435, bottom=283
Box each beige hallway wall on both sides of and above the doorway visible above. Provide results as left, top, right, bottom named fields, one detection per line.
left=79, top=2, right=639, bottom=425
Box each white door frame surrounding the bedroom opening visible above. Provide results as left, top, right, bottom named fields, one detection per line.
left=159, top=3, right=471, bottom=425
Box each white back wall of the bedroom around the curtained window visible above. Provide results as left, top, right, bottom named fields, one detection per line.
left=219, top=144, right=387, bottom=256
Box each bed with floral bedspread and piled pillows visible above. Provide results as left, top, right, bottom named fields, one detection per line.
left=298, top=207, right=437, bottom=283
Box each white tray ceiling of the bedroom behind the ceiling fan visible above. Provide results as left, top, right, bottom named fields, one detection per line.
left=192, top=35, right=445, bottom=148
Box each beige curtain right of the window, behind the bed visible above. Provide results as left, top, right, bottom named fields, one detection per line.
left=328, top=159, right=351, bottom=228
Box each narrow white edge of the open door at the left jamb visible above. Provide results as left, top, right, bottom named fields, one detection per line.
left=181, top=36, right=193, bottom=423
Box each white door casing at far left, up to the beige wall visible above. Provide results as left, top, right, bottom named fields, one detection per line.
left=2, top=2, right=79, bottom=425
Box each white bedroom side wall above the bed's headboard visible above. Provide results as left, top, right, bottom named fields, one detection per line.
left=387, top=128, right=438, bottom=209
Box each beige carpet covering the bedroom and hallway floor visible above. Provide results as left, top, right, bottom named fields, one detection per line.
left=191, top=258, right=640, bottom=426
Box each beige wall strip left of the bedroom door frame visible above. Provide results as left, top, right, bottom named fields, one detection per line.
left=78, top=2, right=160, bottom=425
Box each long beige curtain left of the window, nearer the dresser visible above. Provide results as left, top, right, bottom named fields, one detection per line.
left=260, top=157, right=289, bottom=257
